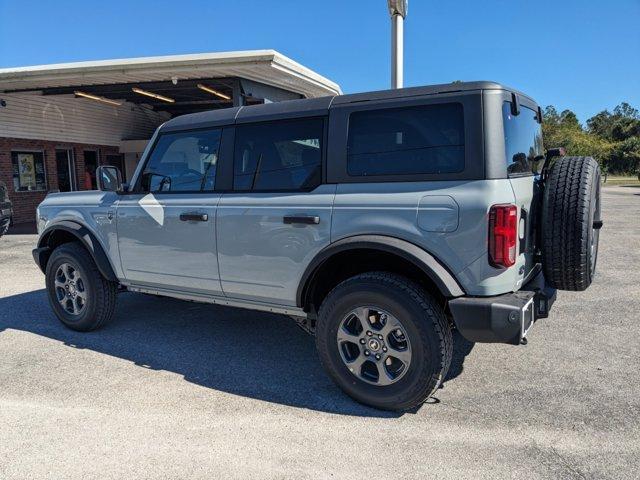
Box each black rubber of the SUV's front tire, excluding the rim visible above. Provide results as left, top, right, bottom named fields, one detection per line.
left=45, top=242, right=118, bottom=332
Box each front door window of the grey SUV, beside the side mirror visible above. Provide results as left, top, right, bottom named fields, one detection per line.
left=141, top=129, right=221, bottom=192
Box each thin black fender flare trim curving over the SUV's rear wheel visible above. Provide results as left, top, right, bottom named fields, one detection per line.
left=296, top=235, right=465, bottom=307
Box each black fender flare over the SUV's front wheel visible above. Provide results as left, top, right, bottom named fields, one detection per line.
left=33, top=220, right=118, bottom=282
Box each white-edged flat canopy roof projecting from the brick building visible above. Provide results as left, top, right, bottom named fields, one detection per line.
left=0, top=50, right=341, bottom=115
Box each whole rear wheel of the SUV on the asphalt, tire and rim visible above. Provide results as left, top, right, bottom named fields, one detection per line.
left=316, top=272, right=453, bottom=410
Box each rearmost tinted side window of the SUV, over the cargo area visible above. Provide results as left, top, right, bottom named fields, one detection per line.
left=347, top=103, right=464, bottom=176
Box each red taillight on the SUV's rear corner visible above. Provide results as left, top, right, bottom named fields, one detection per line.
left=489, top=205, right=518, bottom=267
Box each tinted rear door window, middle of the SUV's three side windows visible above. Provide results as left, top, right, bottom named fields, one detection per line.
left=233, top=118, right=324, bottom=191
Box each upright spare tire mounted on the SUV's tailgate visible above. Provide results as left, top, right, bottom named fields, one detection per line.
left=541, top=157, right=602, bottom=291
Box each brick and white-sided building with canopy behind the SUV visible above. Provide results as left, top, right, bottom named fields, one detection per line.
left=0, top=50, right=341, bottom=223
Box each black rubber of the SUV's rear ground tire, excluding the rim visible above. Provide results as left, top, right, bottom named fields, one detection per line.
left=316, top=272, right=453, bottom=411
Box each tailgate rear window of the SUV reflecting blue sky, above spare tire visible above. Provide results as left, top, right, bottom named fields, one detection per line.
left=502, top=102, right=544, bottom=176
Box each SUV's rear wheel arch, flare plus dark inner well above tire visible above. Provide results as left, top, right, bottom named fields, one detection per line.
left=296, top=235, right=465, bottom=311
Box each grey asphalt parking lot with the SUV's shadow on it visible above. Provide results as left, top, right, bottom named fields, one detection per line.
left=0, top=187, right=640, bottom=479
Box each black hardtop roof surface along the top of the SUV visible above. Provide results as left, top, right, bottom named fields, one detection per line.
left=160, top=81, right=537, bottom=131
